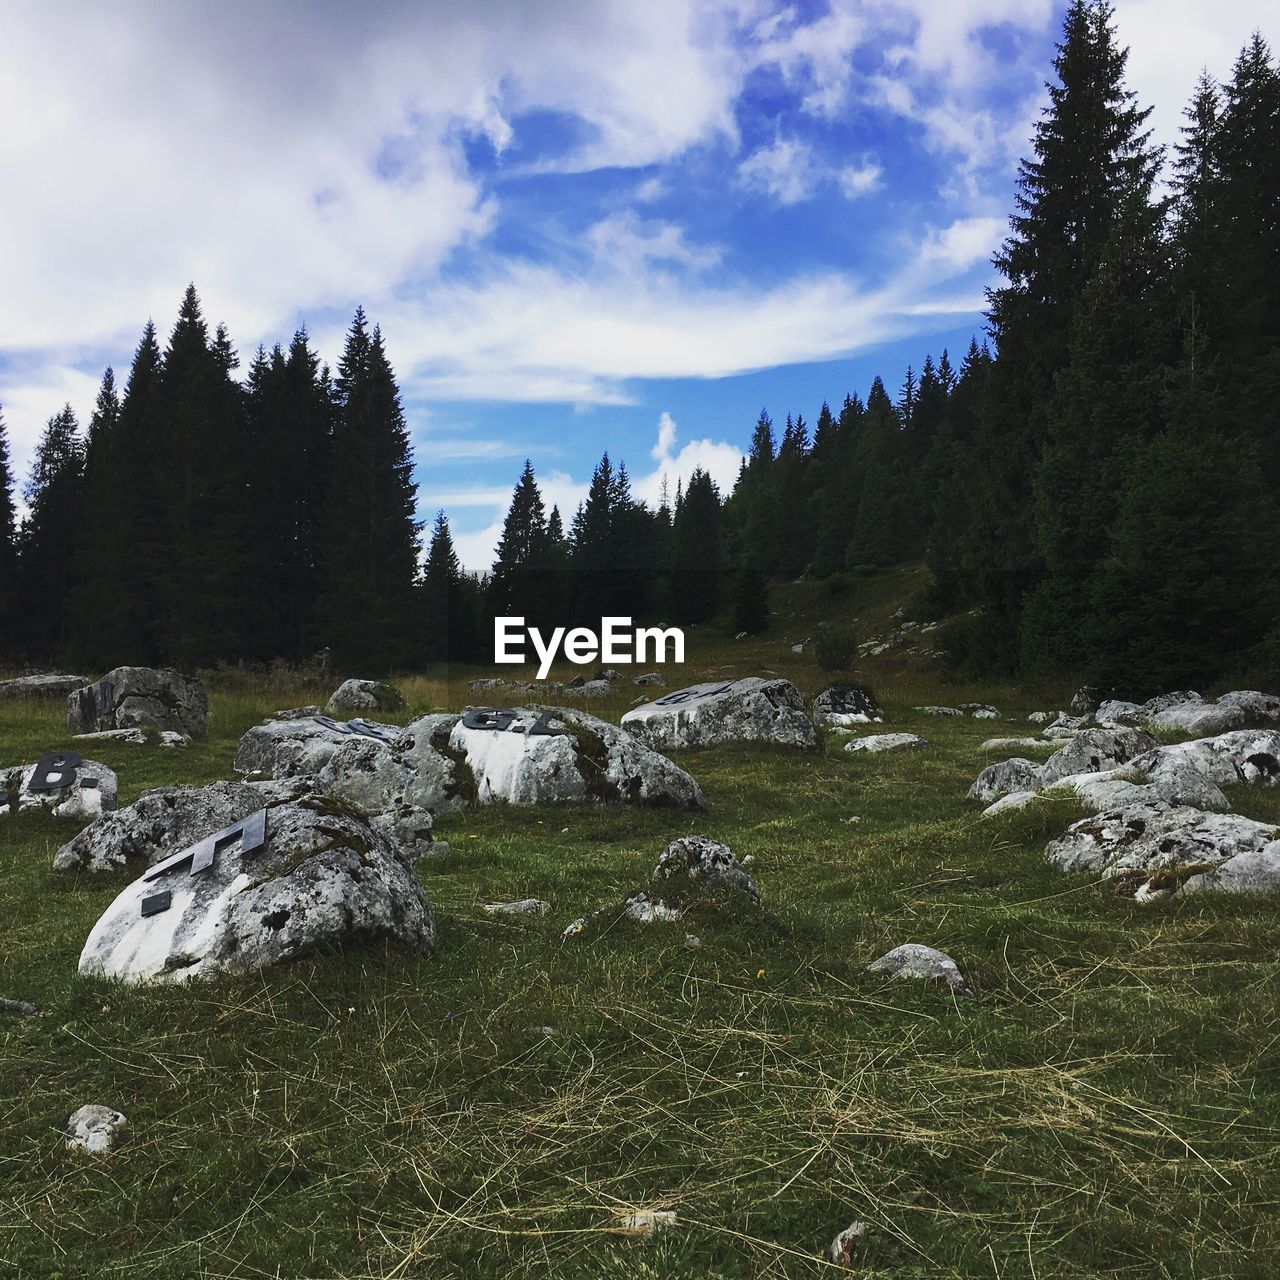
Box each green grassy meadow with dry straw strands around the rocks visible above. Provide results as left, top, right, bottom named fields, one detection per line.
left=0, top=576, right=1280, bottom=1280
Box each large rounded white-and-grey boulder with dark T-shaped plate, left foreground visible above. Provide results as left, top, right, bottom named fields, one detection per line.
left=79, top=796, right=435, bottom=983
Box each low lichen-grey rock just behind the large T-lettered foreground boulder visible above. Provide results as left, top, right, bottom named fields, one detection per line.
left=54, top=782, right=282, bottom=872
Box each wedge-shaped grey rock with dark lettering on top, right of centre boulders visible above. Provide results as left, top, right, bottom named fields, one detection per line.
left=622, top=676, right=818, bottom=751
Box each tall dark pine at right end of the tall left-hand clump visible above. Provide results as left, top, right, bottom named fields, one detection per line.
left=315, top=308, right=422, bottom=671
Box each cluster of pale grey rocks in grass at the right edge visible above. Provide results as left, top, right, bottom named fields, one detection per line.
left=969, top=690, right=1280, bottom=901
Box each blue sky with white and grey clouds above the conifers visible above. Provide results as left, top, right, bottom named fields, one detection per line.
left=0, top=0, right=1274, bottom=570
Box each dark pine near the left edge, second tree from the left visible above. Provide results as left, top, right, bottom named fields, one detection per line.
left=18, top=404, right=84, bottom=660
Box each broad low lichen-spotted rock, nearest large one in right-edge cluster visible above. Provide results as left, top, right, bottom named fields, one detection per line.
left=1044, top=801, right=1280, bottom=900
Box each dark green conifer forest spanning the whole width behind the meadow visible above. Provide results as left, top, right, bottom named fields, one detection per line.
left=0, top=0, right=1280, bottom=694
